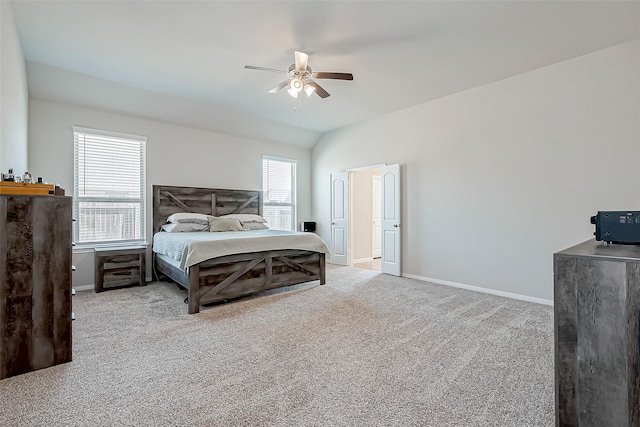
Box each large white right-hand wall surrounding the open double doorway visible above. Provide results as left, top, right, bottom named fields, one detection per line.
left=312, top=40, right=640, bottom=300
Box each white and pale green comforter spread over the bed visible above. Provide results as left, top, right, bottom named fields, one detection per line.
left=153, top=230, right=329, bottom=270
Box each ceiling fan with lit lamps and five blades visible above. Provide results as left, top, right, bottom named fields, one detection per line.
left=244, top=51, right=353, bottom=98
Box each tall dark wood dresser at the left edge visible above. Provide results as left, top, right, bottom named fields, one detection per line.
left=0, top=195, right=72, bottom=379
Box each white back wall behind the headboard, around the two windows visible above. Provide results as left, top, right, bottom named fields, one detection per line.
left=29, top=99, right=311, bottom=286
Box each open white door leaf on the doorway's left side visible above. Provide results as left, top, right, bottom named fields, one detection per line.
left=330, top=172, right=349, bottom=265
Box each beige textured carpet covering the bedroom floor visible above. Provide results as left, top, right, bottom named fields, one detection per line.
left=0, top=267, right=554, bottom=427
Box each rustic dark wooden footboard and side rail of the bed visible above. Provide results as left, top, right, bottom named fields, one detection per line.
left=155, top=250, right=326, bottom=314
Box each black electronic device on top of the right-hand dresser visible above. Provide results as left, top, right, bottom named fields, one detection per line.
left=591, top=211, right=640, bottom=245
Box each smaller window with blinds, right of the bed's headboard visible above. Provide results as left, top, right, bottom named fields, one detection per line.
left=262, top=156, right=296, bottom=231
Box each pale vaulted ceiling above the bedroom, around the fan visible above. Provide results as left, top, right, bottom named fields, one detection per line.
left=12, top=0, right=640, bottom=148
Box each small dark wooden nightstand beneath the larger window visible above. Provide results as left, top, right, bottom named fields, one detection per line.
left=94, top=246, right=147, bottom=292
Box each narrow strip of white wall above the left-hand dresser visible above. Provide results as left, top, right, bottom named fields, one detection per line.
left=0, top=1, right=29, bottom=175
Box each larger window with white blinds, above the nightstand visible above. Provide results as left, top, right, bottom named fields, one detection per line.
left=73, top=126, right=147, bottom=246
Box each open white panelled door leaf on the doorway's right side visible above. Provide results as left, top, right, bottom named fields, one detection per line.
left=381, top=164, right=402, bottom=276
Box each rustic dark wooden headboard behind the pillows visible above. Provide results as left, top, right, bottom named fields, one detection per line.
left=153, top=185, right=263, bottom=233
